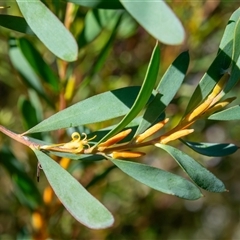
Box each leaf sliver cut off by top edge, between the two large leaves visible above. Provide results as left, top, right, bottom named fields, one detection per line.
left=64, top=0, right=123, bottom=9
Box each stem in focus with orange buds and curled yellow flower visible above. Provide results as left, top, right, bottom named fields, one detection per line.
left=0, top=74, right=235, bottom=159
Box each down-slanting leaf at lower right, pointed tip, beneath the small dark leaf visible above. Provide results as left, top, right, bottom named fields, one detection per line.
left=156, top=143, right=226, bottom=192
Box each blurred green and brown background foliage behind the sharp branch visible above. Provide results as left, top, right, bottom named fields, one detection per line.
left=0, top=1, right=240, bottom=240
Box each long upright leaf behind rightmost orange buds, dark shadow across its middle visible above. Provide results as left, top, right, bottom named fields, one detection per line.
left=186, top=9, right=240, bottom=114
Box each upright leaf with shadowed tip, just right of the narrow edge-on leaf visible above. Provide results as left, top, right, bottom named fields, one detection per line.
left=136, top=52, right=189, bottom=135
